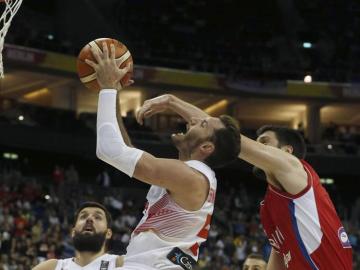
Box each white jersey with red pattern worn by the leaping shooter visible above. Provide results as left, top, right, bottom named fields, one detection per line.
left=124, top=160, right=217, bottom=270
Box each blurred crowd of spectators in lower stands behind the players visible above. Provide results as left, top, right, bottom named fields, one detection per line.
left=0, top=160, right=360, bottom=270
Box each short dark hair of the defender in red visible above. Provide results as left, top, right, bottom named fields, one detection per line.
left=256, top=125, right=306, bottom=159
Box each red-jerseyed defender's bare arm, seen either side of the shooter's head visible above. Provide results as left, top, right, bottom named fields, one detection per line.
left=136, top=94, right=307, bottom=194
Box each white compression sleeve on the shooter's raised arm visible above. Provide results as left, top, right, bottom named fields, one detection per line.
left=96, top=89, right=144, bottom=177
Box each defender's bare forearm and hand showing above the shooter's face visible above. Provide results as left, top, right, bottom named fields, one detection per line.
left=136, top=94, right=209, bottom=124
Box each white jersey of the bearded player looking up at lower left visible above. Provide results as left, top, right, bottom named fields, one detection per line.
left=55, top=254, right=119, bottom=270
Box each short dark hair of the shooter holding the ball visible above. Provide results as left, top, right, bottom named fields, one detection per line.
left=205, top=115, right=240, bottom=168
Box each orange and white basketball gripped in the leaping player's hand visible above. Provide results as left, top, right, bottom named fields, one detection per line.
left=76, top=38, right=133, bottom=91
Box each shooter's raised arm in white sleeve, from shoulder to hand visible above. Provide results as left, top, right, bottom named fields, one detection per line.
left=87, top=44, right=209, bottom=210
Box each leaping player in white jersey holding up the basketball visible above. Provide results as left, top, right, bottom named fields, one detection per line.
left=86, top=44, right=240, bottom=270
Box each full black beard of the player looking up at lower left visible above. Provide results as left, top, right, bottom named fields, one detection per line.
left=73, top=232, right=106, bottom=252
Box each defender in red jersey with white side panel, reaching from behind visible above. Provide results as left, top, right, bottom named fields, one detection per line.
left=239, top=126, right=352, bottom=270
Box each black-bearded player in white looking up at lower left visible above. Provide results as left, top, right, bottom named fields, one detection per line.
left=33, top=202, right=123, bottom=270
